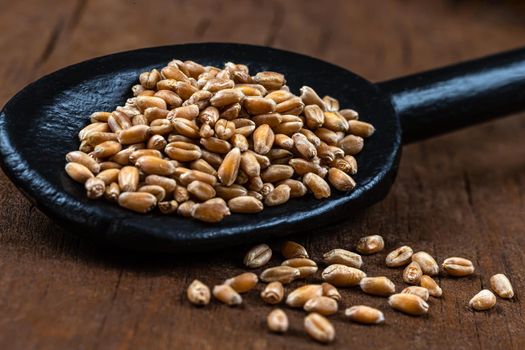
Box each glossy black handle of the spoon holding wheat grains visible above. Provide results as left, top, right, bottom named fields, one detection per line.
left=378, top=48, right=525, bottom=143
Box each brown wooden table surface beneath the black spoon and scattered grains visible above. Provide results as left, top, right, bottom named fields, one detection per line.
left=0, top=0, right=525, bottom=349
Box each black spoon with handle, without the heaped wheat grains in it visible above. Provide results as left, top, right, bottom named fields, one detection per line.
left=0, top=43, right=525, bottom=251
